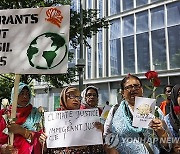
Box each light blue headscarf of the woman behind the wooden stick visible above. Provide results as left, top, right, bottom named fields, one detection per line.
left=11, top=82, right=31, bottom=107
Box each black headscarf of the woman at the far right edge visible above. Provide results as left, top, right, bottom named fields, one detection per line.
left=170, top=84, right=180, bottom=132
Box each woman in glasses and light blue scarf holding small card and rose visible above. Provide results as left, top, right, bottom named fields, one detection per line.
left=104, top=75, right=169, bottom=154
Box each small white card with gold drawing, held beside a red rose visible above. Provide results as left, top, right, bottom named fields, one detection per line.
left=132, top=97, right=156, bottom=128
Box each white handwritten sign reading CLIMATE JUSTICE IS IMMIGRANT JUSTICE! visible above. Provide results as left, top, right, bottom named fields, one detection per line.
left=45, top=109, right=103, bottom=148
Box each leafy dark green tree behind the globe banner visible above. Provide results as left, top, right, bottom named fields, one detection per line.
left=0, top=0, right=109, bottom=96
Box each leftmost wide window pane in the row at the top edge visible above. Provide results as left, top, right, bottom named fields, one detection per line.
left=110, top=0, right=120, bottom=15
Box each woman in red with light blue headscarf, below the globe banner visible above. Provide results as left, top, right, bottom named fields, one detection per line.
left=0, top=83, right=42, bottom=154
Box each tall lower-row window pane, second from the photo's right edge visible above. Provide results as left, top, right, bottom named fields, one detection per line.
left=152, top=29, right=167, bottom=70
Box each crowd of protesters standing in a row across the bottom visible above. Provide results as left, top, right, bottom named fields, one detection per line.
left=0, top=74, right=180, bottom=154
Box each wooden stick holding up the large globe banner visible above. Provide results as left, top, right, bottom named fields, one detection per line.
left=9, top=74, right=21, bottom=145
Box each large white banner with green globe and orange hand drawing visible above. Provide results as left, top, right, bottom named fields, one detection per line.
left=0, top=5, right=70, bottom=74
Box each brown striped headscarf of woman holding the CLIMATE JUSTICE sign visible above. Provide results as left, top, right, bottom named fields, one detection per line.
left=60, top=86, right=78, bottom=110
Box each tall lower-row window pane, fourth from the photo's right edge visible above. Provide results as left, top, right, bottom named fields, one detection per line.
left=123, top=36, right=135, bottom=74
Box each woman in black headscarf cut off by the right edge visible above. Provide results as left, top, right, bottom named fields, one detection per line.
left=165, top=84, right=180, bottom=153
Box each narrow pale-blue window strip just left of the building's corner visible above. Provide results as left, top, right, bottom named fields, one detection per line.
left=98, top=31, right=103, bottom=77
